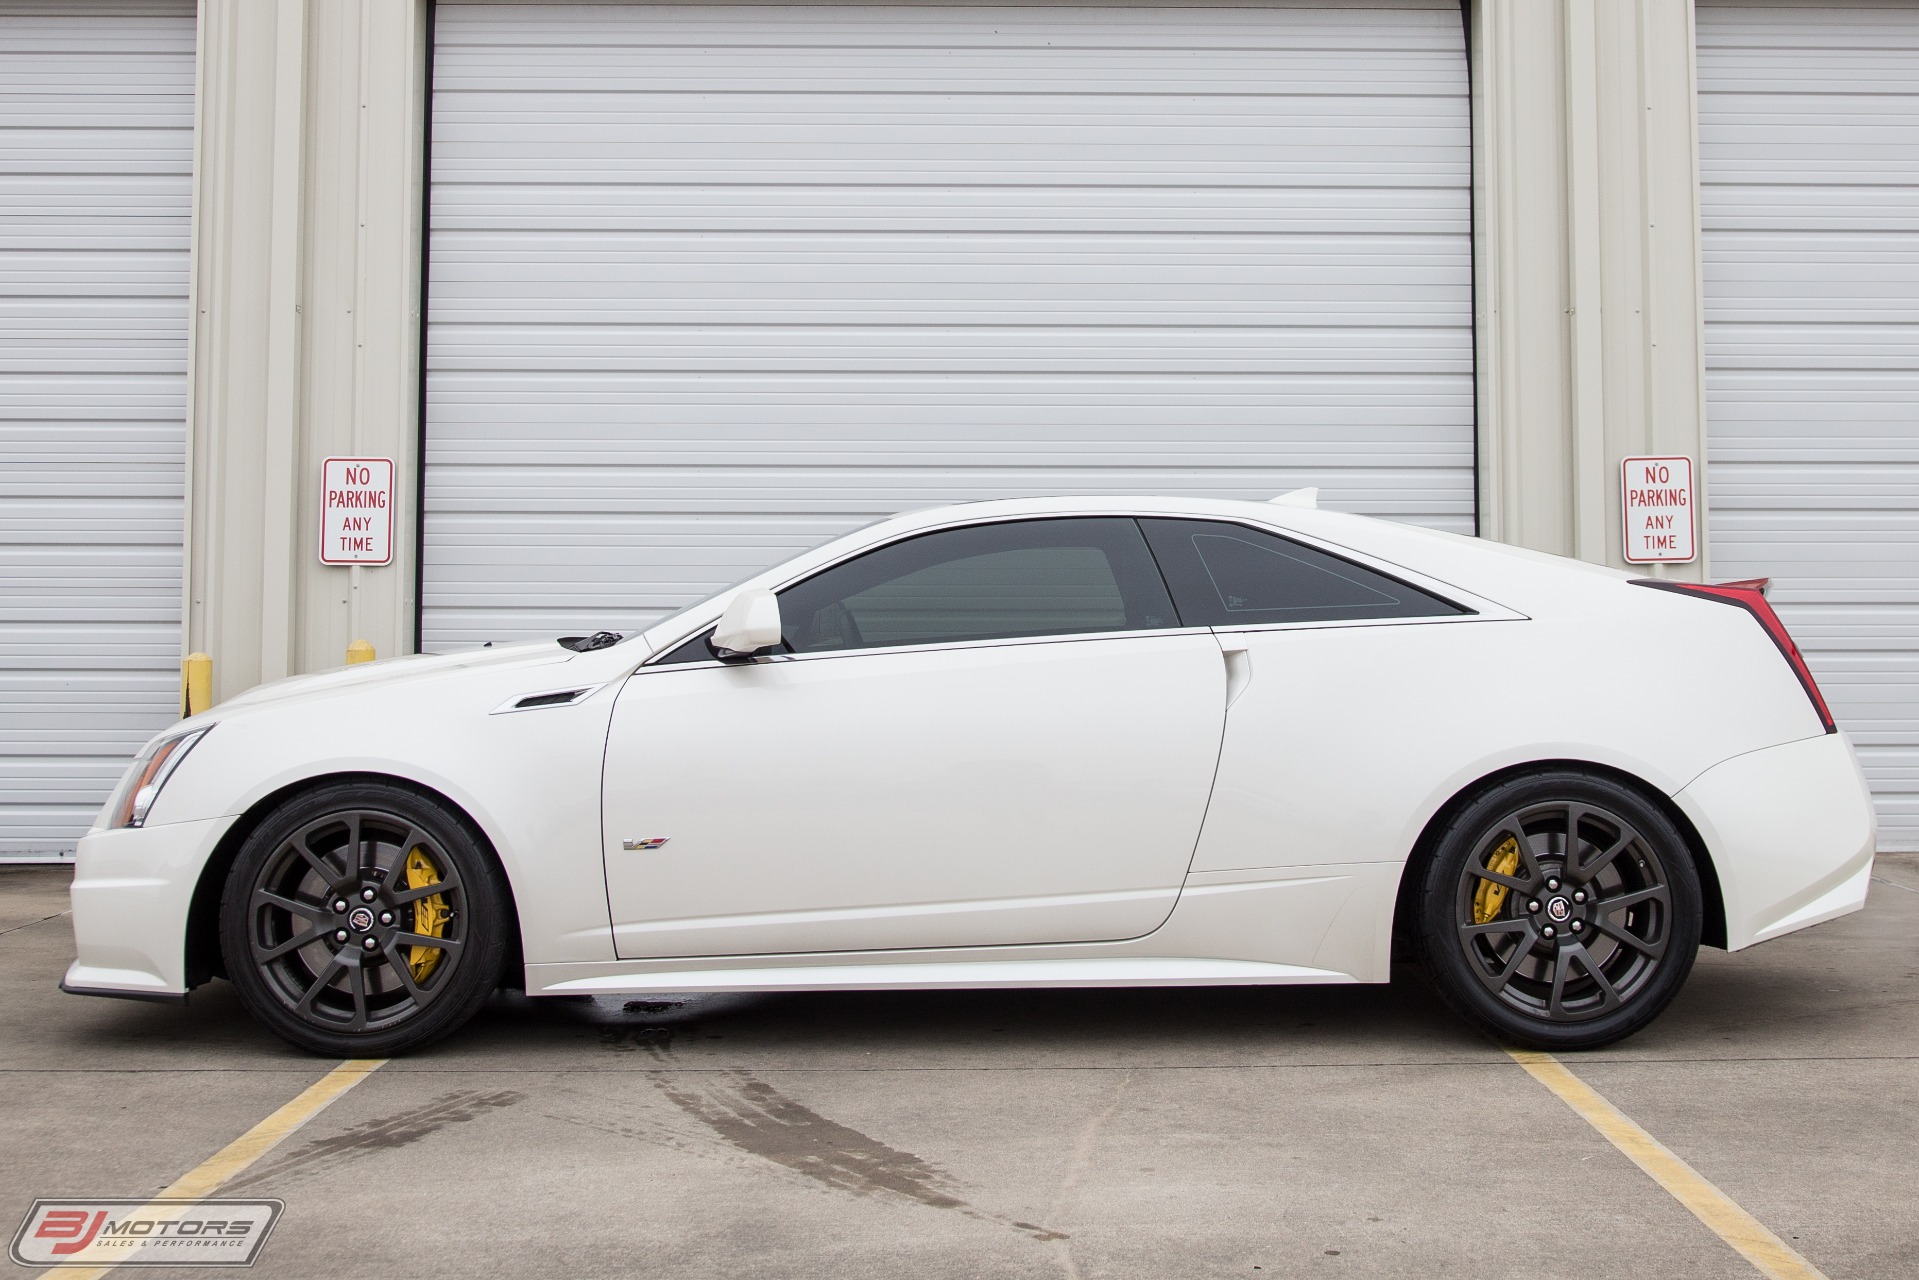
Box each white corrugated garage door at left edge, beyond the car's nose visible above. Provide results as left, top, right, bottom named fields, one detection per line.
left=0, top=0, right=194, bottom=856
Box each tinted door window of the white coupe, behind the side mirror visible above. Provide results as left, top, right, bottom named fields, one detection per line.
left=779, top=518, right=1178, bottom=652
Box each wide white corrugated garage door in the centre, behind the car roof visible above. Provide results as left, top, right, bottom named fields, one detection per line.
left=424, top=0, right=1472, bottom=649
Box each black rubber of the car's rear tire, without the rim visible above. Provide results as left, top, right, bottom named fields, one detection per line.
left=1416, top=770, right=1704, bottom=1050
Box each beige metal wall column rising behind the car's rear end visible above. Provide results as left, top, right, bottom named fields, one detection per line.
left=1470, top=0, right=1706, bottom=578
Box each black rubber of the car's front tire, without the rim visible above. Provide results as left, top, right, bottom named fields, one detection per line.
left=221, top=783, right=510, bottom=1057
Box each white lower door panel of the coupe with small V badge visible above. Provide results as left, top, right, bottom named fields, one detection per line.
left=604, top=631, right=1226, bottom=960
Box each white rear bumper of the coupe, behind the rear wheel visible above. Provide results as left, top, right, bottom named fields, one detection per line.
left=1673, top=733, right=1877, bottom=952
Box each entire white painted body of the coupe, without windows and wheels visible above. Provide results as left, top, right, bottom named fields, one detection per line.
left=69, top=499, right=1871, bottom=990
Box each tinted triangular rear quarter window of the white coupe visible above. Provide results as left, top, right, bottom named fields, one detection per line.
left=1140, top=520, right=1472, bottom=628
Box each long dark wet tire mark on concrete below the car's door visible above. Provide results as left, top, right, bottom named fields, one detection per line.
left=654, top=1071, right=1067, bottom=1240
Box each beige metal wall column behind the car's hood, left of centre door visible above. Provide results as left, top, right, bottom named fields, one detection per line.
left=186, top=0, right=426, bottom=699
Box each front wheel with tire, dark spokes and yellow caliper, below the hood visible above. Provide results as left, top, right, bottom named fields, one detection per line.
left=221, top=783, right=510, bottom=1057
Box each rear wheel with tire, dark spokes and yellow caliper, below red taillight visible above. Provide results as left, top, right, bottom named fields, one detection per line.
left=1414, top=770, right=1702, bottom=1050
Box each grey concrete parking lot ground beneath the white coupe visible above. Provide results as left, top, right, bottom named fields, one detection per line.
left=0, top=856, right=1919, bottom=1280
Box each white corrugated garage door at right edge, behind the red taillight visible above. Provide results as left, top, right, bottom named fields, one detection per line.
left=1698, top=4, right=1919, bottom=848
